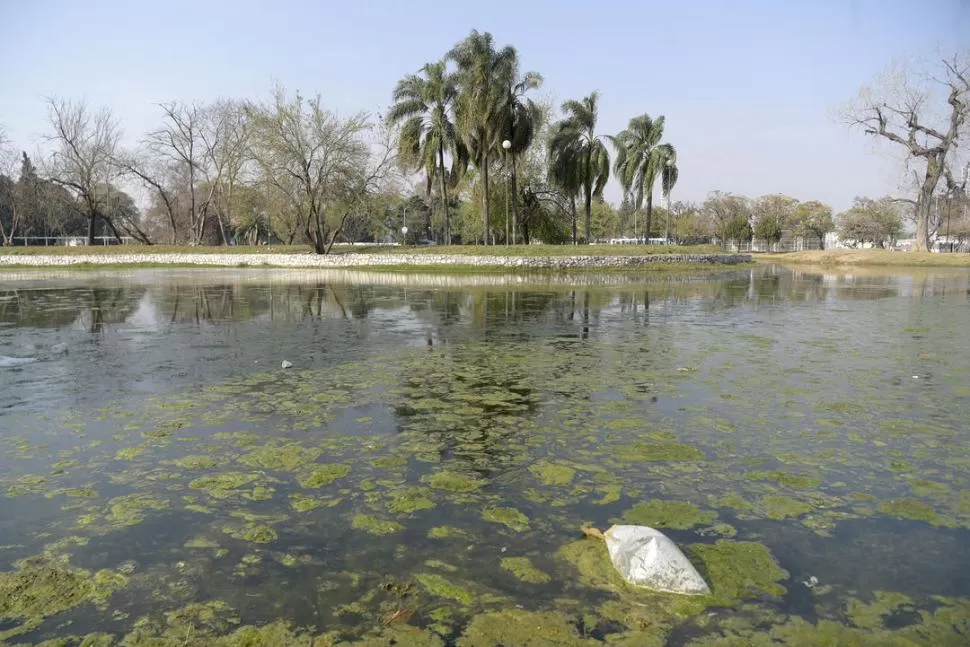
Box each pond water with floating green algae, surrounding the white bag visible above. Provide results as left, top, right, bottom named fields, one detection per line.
left=0, top=268, right=970, bottom=644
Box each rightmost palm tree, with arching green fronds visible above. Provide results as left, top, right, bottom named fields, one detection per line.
left=610, top=114, right=677, bottom=238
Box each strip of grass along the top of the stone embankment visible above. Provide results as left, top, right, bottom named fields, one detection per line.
left=0, top=245, right=722, bottom=258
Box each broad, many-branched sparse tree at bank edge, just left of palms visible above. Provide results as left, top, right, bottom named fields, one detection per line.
left=247, top=86, right=395, bottom=254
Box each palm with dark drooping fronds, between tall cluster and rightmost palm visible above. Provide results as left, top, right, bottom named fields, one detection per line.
left=549, top=92, right=610, bottom=243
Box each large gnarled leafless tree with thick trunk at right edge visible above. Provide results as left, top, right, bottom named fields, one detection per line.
left=845, top=55, right=970, bottom=251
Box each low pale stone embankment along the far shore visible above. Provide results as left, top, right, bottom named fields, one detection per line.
left=0, top=253, right=751, bottom=270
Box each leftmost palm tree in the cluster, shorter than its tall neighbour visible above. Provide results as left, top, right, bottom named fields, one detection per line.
left=387, top=61, right=468, bottom=245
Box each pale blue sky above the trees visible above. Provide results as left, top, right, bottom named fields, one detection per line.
left=0, top=0, right=970, bottom=210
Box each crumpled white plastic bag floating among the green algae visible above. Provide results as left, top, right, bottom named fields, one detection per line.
left=603, top=526, right=711, bottom=595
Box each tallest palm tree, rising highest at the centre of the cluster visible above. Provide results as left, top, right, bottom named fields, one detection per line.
left=447, top=29, right=518, bottom=244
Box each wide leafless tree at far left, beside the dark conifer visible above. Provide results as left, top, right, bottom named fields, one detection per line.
left=45, top=98, right=121, bottom=245
